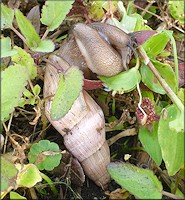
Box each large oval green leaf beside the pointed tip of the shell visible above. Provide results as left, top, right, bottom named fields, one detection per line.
left=107, top=163, right=162, bottom=199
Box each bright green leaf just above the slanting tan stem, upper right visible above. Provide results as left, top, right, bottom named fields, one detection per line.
left=142, top=31, right=172, bottom=57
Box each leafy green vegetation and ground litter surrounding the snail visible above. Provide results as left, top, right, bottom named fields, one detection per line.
left=1, top=0, right=185, bottom=199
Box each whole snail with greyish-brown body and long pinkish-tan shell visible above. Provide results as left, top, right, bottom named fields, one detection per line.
left=43, top=23, right=135, bottom=189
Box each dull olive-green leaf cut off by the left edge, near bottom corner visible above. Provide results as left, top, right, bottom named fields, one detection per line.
left=1, top=156, right=18, bottom=192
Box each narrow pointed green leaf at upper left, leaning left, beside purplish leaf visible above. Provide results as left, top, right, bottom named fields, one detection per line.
left=15, top=9, right=41, bottom=48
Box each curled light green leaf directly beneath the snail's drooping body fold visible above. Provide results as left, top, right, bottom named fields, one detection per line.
left=98, top=67, right=141, bottom=93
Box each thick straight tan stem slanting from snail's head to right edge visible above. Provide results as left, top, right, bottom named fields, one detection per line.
left=138, top=46, right=184, bottom=112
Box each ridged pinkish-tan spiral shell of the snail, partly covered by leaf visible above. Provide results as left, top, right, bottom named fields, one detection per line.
left=44, top=55, right=110, bottom=188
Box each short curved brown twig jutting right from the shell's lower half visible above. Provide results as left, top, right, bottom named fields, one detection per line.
left=107, top=128, right=137, bottom=146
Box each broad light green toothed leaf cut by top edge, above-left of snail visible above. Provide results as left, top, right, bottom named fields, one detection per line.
left=41, top=0, right=74, bottom=31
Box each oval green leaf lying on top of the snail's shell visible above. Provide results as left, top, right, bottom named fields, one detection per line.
left=51, top=67, right=83, bottom=120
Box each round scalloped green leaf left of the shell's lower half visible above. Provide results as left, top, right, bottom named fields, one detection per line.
left=28, top=140, right=62, bottom=171
